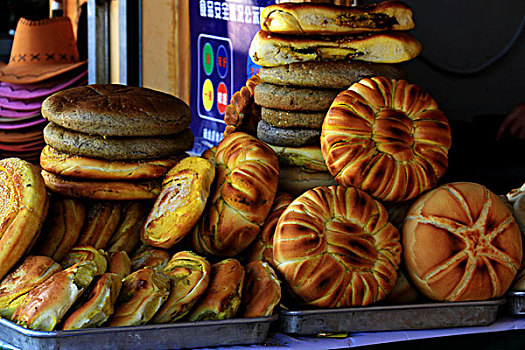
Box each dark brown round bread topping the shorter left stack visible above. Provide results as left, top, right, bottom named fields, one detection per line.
left=42, top=84, right=191, bottom=136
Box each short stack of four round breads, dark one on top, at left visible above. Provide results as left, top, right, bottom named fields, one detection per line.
left=40, top=84, right=193, bottom=200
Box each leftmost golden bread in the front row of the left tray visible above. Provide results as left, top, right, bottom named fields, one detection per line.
left=0, top=255, right=62, bottom=320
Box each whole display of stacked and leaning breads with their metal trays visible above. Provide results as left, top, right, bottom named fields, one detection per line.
left=0, top=1, right=523, bottom=348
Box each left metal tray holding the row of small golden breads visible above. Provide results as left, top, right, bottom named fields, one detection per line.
left=0, top=315, right=277, bottom=350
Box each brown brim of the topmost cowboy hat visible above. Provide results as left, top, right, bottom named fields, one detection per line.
left=0, top=60, right=87, bottom=84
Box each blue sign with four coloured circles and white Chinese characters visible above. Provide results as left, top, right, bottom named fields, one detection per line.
left=189, top=0, right=275, bottom=155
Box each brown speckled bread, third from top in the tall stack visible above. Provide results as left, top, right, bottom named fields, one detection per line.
left=259, top=60, right=406, bottom=91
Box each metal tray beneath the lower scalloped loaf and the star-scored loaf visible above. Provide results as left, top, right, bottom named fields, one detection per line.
left=278, top=299, right=505, bottom=335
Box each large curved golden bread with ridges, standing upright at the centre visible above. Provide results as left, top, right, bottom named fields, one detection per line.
left=192, top=132, right=279, bottom=256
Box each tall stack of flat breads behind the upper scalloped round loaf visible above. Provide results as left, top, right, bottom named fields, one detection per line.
left=250, top=1, right=421, bottom=194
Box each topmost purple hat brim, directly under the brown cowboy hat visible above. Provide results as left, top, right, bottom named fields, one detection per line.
left=0, top=70, right=87, bottom=99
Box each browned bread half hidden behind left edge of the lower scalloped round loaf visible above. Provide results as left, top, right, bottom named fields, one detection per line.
left=246, top=192, right=295, bottom=266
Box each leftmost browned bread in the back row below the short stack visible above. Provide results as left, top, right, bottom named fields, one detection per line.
left=36, top=196, right=86, bottom=261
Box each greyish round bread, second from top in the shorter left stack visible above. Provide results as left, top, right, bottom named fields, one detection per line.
left=44, top=123, right=194, bottom=160
